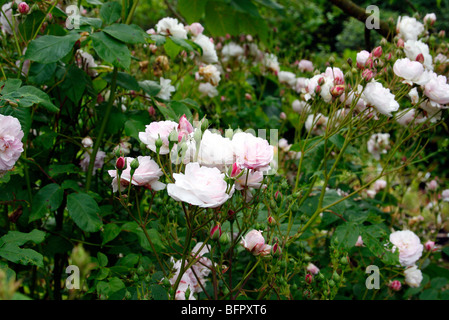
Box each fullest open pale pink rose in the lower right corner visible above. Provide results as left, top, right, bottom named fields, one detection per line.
left=390, top=230, right=424, bottom=267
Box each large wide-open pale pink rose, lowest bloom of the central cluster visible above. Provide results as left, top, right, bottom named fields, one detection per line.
left=167, top=162, right=235, bottom=208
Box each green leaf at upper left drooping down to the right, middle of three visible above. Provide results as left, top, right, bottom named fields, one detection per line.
left=91, top=32, right=131, bottom=69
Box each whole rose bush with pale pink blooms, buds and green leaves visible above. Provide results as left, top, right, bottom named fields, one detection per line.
left=0, top=0, right=449, bottom=300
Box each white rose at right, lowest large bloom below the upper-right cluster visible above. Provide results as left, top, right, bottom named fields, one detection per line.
left=363, top=81, right=399, bottom=117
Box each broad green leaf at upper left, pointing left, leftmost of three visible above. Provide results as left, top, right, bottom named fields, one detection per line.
left=25, top=33, right=80, bottom=64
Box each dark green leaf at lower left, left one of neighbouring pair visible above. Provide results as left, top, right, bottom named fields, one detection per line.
left=28, top=183, right=64, bottom=222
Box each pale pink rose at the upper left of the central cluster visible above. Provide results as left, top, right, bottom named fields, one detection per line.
left=139, top=120, right=178, bottom=154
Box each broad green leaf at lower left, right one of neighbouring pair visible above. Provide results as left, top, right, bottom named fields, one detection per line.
left=67, top=193, right=102, bottom=232
